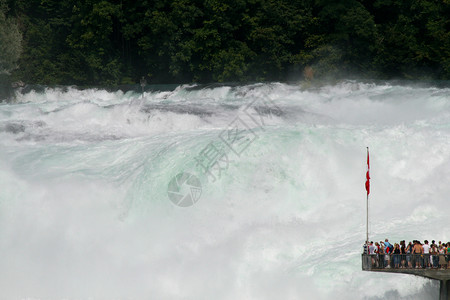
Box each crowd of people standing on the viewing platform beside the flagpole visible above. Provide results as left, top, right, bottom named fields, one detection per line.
left=364, top=239, right=450, bottom=269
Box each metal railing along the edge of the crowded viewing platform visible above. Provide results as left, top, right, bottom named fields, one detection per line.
left=361, top=253, right=450, bottom=271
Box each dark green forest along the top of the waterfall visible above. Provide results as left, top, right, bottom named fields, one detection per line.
left=0, top=0, right=450, bottom=86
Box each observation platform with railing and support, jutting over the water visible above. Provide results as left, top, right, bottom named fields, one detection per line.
left=361, top=254, right=450, bottom=300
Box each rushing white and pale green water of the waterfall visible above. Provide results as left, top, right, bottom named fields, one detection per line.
left=0, top=81, right=450, bottom=299
